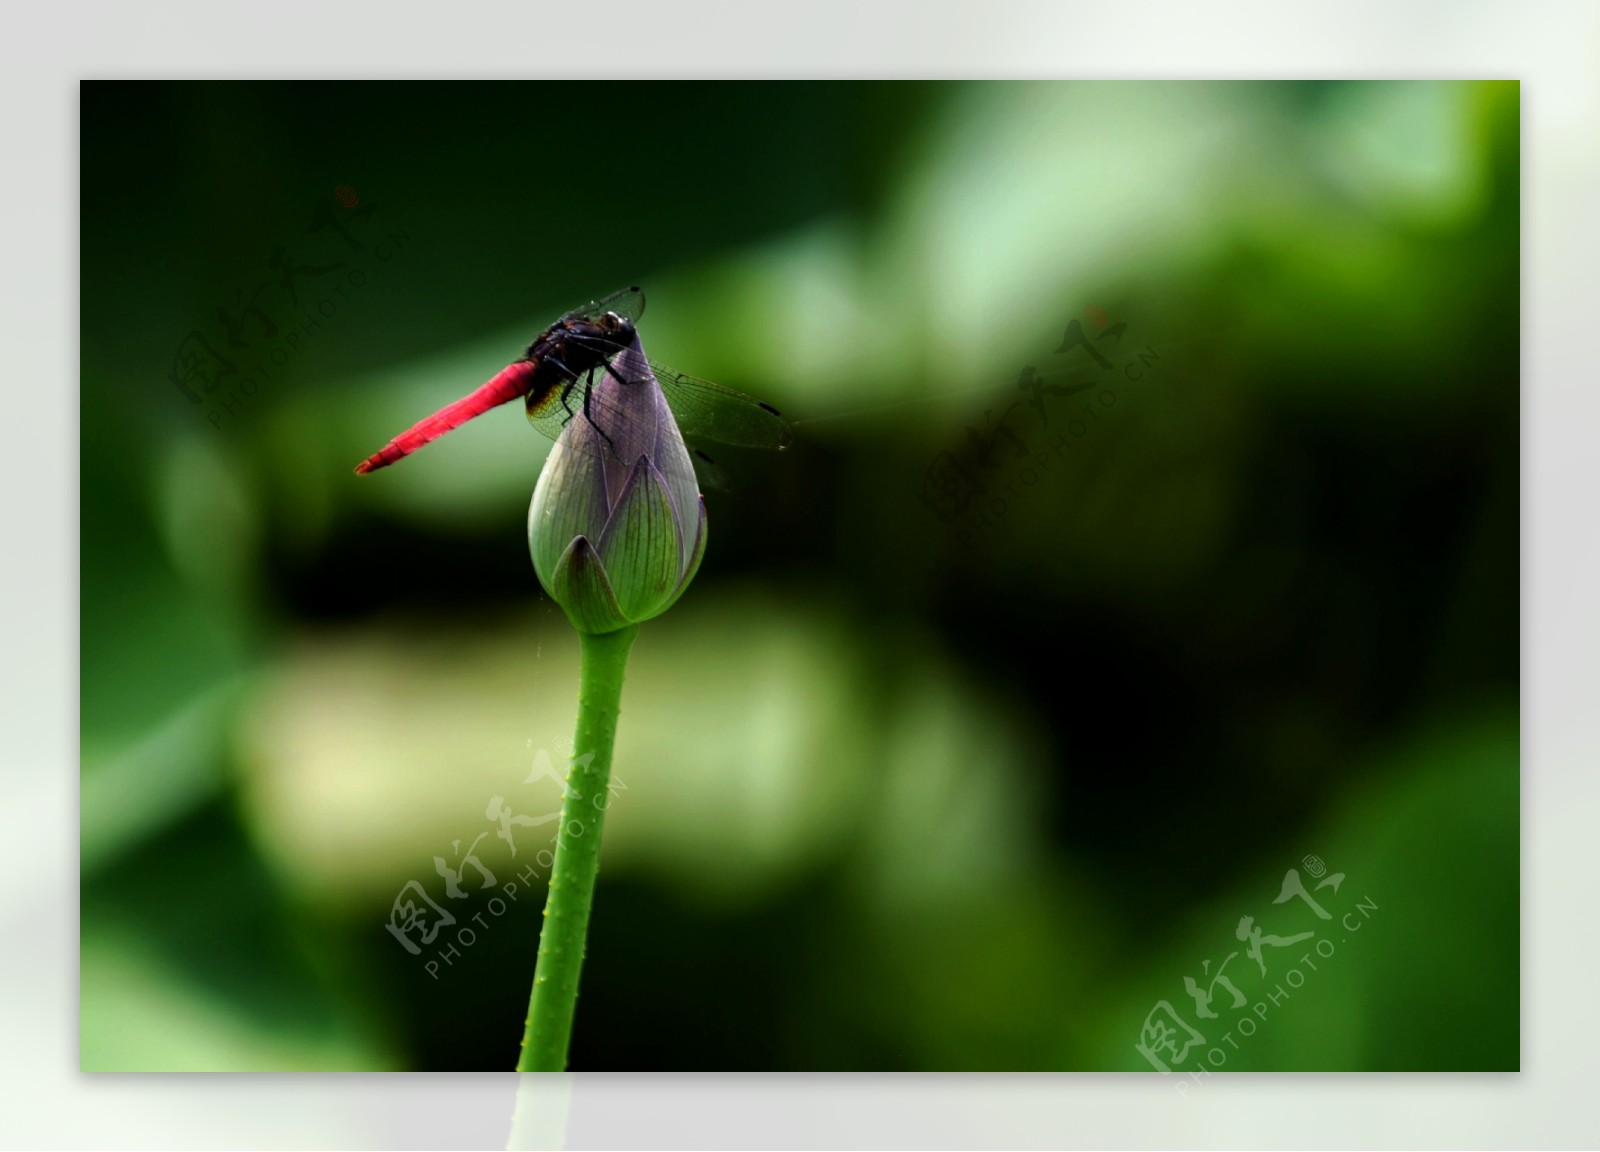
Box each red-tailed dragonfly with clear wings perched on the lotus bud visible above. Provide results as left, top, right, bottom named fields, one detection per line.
left=355, top=286, right=794, bottom=475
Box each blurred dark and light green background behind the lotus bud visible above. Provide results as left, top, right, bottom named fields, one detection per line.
left=82, top=82, right=1520, bottom=1070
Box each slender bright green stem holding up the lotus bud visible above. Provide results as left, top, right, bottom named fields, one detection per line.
left=517, top=624, right=638, bottom=1072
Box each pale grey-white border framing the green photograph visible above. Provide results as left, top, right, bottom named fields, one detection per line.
left=0, top=0, right=1600, bottom=1149
